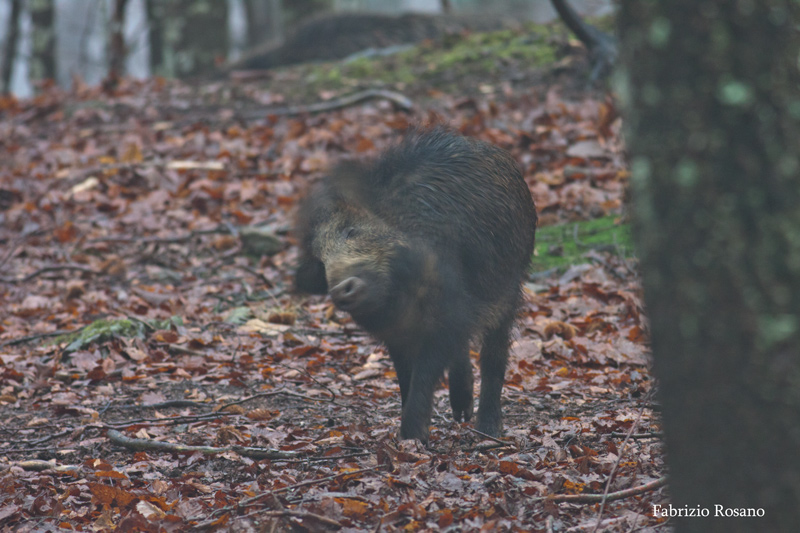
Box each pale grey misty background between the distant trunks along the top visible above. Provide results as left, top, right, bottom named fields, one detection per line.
left=0, top=0, right=613, bottom=97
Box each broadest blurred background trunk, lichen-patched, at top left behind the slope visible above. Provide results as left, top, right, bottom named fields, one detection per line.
left=147, top=0, right=228, bottom=77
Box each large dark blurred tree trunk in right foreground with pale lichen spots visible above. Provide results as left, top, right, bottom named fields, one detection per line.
left=619, top=0, right=800, bottom=532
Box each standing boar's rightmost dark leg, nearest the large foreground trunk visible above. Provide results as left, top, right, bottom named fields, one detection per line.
left=477, top=316, right=514, bottom=437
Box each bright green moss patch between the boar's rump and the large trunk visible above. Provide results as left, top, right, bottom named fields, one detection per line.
left=531, top=216, right=633, bottom=272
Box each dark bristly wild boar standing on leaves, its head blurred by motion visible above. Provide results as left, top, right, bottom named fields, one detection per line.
left=296, top=127, right=536, bottom=440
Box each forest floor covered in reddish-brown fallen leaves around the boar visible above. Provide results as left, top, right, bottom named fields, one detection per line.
left=0, top=19, right=669, bottom=531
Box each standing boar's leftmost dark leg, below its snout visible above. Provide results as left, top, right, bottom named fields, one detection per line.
left=400, top=334, right=468, bottom=443
